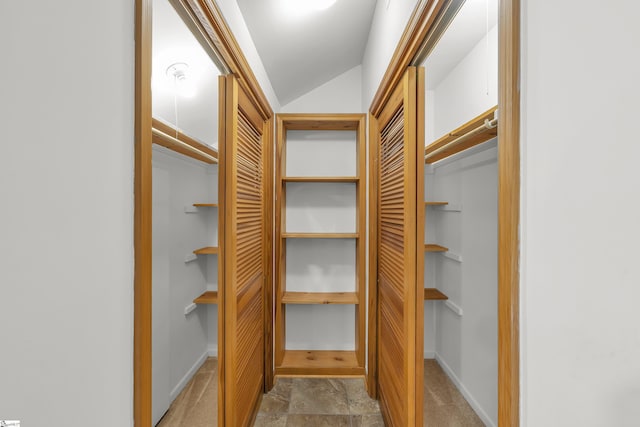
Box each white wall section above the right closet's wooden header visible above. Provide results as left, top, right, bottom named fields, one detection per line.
left=362, top=0, right=417, bottom=110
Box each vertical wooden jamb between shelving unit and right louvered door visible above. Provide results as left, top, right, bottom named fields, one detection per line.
left=367, top=113, right=379, bottom=399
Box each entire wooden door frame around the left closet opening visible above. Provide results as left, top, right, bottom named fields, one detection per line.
left=133, top=0, right=273, bottom=427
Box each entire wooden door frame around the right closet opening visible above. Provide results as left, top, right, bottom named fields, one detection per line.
left=367, top=0, right=520, bottom=427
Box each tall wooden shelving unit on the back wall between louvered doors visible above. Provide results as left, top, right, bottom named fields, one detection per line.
left=274, top=114, right=366, bottom=376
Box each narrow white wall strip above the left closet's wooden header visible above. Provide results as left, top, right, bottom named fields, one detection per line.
left=215, top=0, right=280, bottom=113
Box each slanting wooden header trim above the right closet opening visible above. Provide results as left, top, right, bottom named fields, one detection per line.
left=369, top=0, right=450, bottom=117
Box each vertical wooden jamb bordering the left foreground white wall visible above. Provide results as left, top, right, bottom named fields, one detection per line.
left=133, top=0, right=153, bottom=427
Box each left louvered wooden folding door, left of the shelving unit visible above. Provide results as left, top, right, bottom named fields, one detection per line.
left=219, top=76, right=271, bottom=427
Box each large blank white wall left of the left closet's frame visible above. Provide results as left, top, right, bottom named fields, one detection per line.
left=0, top=0, right=134, bottom=427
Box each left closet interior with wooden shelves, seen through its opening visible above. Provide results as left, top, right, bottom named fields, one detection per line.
left=151, top=0, right=221, bottom=427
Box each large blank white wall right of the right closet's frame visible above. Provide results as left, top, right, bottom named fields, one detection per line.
left=520, top=0, right=640, bottom=427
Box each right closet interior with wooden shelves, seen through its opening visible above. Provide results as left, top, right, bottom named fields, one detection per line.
left=422, top=0, right=498, bottom=426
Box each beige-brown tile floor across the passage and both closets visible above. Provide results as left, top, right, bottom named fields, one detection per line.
left=157, top=358, right=484, bottom=427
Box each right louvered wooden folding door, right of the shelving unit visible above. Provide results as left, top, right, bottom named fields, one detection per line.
left=375, top=68, right=424, bottom=427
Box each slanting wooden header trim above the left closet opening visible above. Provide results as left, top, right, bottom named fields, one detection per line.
left=180, top=0, right=273, bottom=118
